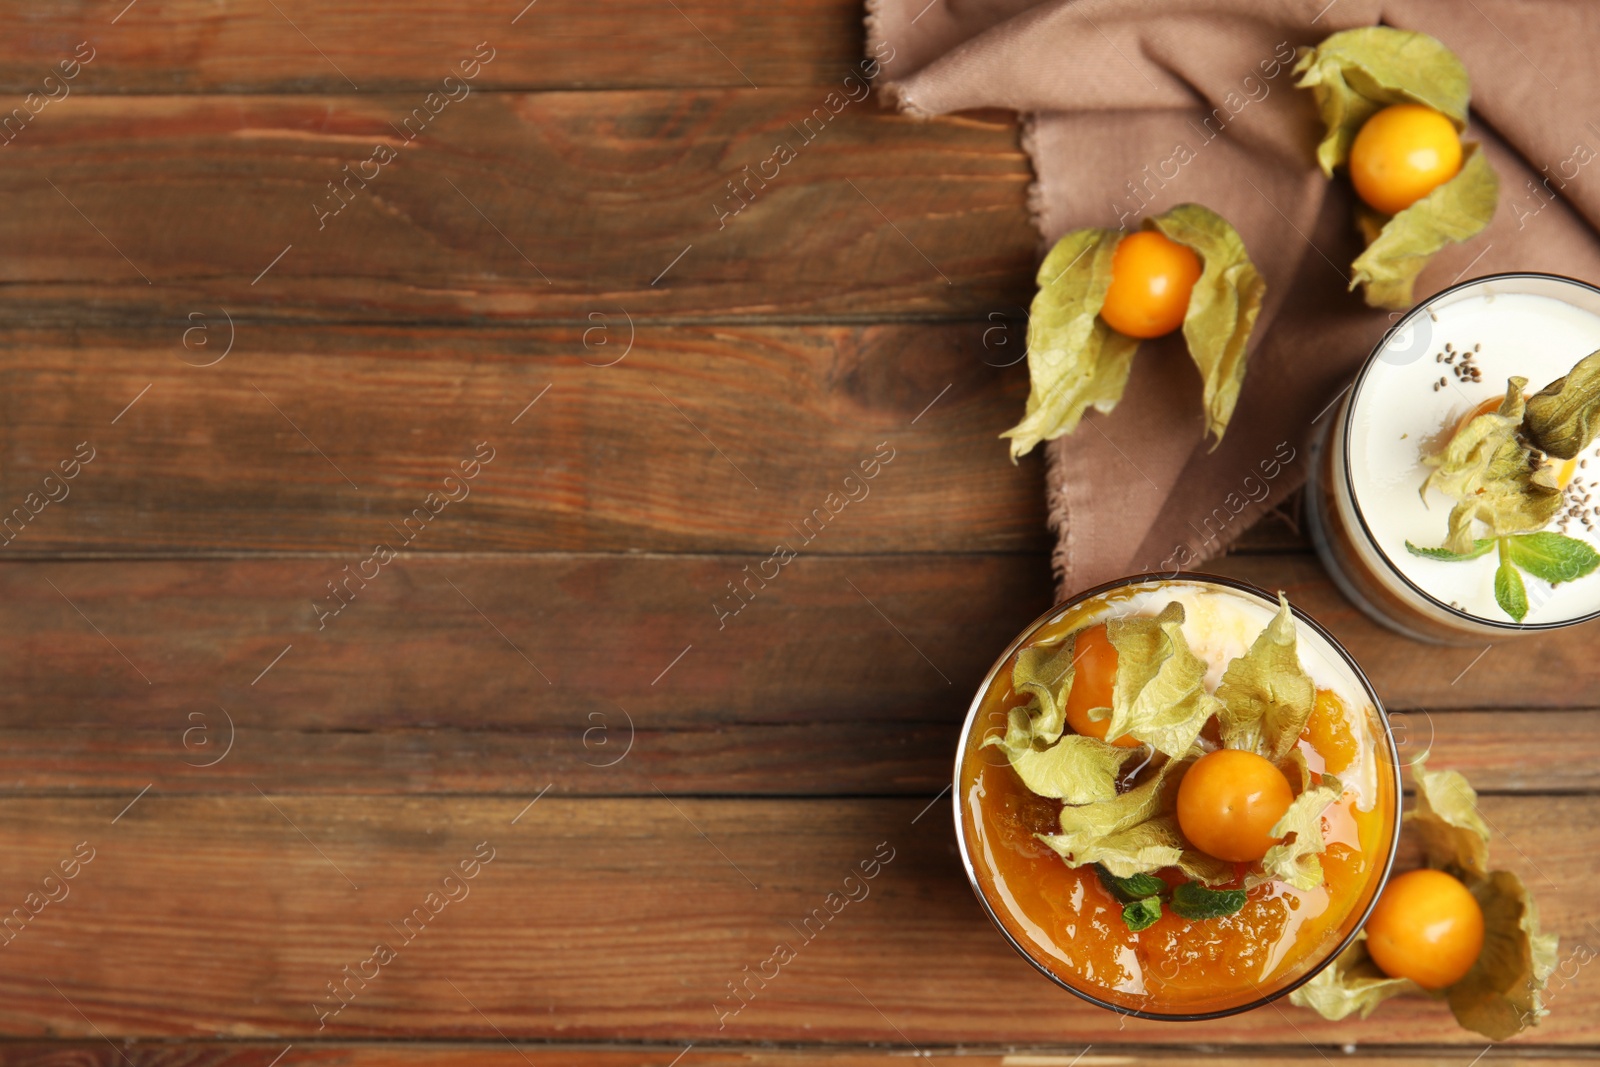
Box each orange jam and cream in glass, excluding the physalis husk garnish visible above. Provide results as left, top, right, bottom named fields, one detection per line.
left=954, top=574, right=1400, bottom=1021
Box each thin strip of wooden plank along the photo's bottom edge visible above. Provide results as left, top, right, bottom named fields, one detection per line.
left=5, top=1040, right=1595, bottom=1067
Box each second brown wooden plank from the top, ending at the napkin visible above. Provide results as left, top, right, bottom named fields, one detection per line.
left=0, top=93, right=1037, bottom=323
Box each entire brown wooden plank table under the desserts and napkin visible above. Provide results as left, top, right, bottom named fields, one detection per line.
left=0, top=0, right=1600, bottom=1067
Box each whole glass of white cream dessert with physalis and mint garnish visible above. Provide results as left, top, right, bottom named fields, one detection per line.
left=1306, top=274, right=1600, bottom=643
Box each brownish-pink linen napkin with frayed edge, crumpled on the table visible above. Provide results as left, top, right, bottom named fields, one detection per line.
left=867, top=0, right=1600, bottom=595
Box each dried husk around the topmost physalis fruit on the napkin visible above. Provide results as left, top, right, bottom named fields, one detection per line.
left=1294, top=26, right=1499, bottom=307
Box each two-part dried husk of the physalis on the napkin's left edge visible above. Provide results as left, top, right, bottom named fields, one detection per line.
left=1002, top=203, right=1266, bottom=461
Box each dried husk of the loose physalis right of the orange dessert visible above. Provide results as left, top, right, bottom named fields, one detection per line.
left=1290, top=757, right=1557, bottom=1041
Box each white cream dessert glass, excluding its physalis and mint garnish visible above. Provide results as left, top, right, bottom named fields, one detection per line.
left=1306, top=274, right=1600, bottom=645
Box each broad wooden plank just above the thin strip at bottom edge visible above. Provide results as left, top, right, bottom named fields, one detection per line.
left=0, top=790, right=1600, bottom=1036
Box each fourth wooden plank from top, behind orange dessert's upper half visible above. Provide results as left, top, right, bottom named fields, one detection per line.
left=0, top=555, right=1600, bottom=795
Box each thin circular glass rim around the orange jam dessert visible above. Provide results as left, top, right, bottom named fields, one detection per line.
left=950, top=571, right=1405, bottom=1022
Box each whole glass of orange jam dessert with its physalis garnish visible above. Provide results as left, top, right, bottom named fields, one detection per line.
left=955, top=576, right=1400, bottom=1019
